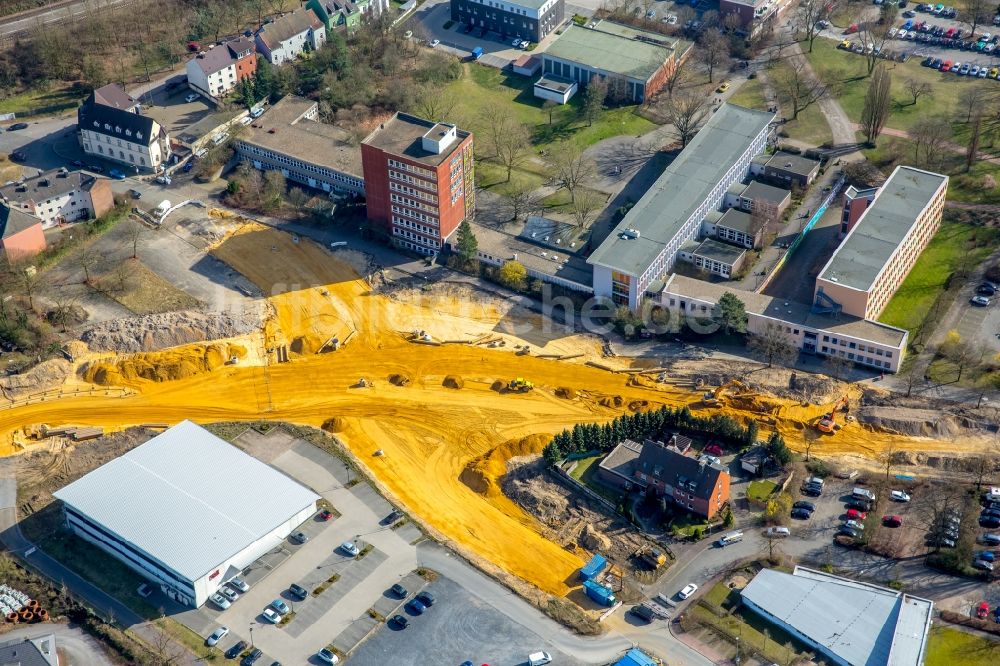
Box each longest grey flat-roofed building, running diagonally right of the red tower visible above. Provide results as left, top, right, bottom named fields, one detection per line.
left=588, top=104, right=774, bottom=310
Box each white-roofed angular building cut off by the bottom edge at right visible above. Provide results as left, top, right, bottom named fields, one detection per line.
left=741, top=567, right=934, bottom=666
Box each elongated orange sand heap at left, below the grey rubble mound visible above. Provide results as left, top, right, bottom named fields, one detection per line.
left=80, top=342, right=247, bottom=386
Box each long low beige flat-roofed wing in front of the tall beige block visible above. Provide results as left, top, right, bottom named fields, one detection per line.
left=659, top=274, right=909, bottom=372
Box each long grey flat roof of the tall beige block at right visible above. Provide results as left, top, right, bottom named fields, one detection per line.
left=820, top=166, right=948, bottom=291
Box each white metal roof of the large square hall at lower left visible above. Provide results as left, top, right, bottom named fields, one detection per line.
left=55, top=421, right=319, bottom=580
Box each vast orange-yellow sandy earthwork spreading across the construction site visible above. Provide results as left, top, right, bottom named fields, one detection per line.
left=0, top=225, right=984, bottom=595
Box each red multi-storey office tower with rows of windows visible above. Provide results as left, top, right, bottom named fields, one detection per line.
left=361, top=113, right=476, bottom=255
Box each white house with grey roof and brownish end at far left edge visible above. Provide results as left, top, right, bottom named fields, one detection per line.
left=0, top=169, right=115, bottom=229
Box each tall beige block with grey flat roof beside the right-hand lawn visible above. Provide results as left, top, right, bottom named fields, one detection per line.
left=814, top=166, right=948, bottom=319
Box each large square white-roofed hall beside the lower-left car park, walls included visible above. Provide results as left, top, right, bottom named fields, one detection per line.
left=54, top=421, right=319, bottom=607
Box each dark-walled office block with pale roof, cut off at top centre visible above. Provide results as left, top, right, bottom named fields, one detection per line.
left=451, top=0, right=566, bottom=42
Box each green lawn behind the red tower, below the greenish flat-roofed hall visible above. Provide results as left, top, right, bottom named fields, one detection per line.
left=448, top=63, right=656, bottom=149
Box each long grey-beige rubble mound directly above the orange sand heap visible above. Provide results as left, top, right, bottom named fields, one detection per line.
left=80, top=310, right=261, bottom=353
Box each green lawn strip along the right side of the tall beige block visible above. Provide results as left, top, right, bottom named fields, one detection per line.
left=879, top=221, right=1000, bottom=335
